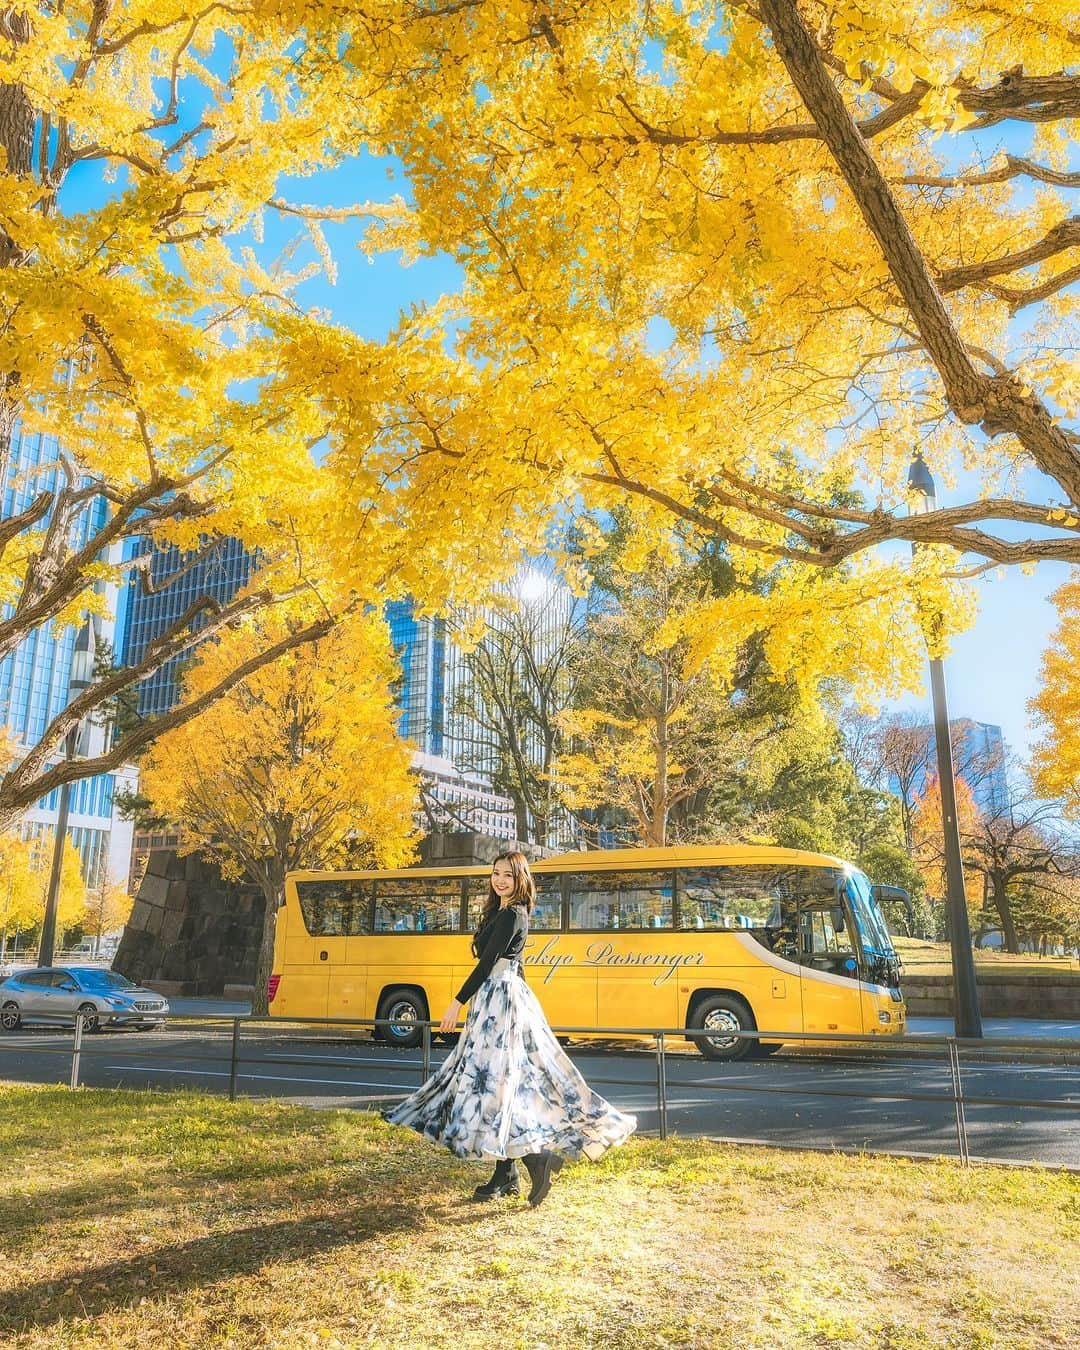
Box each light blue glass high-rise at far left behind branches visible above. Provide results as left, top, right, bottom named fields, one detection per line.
left=0, top=427, right=134, bottom=886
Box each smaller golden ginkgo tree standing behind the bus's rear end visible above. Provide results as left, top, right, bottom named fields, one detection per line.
left=133, top=613, right=417, bottom=1013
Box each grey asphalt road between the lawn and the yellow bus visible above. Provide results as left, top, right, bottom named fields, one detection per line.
left=0, top=1022, right=1080, bottom=1168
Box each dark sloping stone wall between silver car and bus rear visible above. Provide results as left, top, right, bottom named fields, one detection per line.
left=112, top=849, right=265, bottom=996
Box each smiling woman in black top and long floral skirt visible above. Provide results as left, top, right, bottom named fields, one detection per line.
left=383, top=852, right=637, bottom=1206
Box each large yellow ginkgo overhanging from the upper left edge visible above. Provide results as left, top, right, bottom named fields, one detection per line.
left=0, top=0, right=526, bottom=825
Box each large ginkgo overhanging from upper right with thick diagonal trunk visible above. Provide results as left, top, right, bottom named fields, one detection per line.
left=318, top=0, right=1080, bottom=691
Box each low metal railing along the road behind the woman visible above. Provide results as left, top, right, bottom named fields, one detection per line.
left=8, top=1013, right=1080, bottom=1166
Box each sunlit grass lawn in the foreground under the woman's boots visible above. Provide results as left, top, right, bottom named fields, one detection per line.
left=0, top=1087, right=1080, bottom=1350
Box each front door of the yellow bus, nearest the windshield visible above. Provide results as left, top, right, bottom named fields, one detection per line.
left=797, top=868, right=865, bottom=1035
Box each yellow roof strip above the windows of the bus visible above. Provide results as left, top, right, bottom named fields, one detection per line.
left=289, top=844, right=851, bottom=880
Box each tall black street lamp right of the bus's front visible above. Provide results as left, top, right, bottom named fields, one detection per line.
left=907, top=451, right=983, bottom=1040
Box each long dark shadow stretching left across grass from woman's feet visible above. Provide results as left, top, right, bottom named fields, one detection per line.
left=0, top=1193, right=464, bottom=1337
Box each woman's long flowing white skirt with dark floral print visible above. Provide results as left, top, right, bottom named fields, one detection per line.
left=383, top=960, right=637, bottom=1160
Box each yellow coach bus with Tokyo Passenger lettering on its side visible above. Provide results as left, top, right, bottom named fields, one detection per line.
left=270, top=845, right=905, bottom=1060
